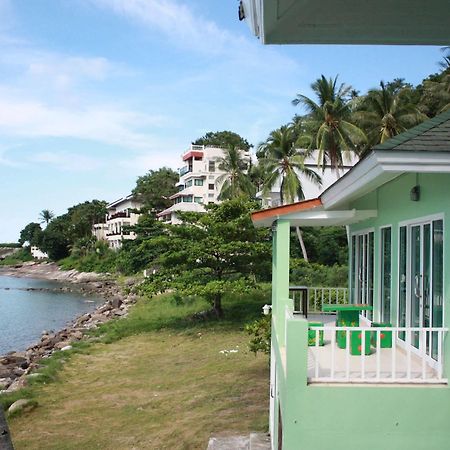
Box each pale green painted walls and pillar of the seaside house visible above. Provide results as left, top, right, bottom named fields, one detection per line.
left=272, top=174, right=450, bottom=450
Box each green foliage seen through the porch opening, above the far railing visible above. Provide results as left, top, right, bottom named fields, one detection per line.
left=289, top=259, right=348, bottom=287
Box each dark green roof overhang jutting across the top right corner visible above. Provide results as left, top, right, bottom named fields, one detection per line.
left=242, top=0, right=450, bottom=45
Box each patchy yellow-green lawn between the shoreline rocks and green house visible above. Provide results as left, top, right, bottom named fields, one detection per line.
left=10, top=294, right=268, bottom=450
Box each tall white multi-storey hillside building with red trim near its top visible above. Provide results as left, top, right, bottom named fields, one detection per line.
left=157, top=145, right=250, bottom=224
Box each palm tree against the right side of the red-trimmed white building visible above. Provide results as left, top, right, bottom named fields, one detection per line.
left=216, top=145, right=255, bottom=200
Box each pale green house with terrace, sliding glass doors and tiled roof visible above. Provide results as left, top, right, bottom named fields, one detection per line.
left=252, top=111, right=450, bottom=450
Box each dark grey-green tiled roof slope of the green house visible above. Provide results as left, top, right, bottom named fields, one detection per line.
left=373, top=109, right=450, bottom=152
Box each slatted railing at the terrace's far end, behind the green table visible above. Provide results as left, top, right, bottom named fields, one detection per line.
left=289, top=286, right=349, bottom=314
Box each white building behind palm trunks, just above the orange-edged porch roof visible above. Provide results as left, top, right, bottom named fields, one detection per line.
left=256, top=150, right=358, bottom=208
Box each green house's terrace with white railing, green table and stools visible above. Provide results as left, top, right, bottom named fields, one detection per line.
left=280, top=286, right=448, bottom=385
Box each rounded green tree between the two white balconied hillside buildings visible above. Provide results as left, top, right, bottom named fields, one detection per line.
left=133, top=167, right=179, bottom=212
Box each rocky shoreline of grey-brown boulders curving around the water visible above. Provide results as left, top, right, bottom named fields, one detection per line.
left=0, top=262, right=137, bottom=395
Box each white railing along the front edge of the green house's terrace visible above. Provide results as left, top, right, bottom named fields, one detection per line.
left=308, top=326, right=448, bottom=384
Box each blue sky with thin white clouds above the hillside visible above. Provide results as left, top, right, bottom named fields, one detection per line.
left=0, top=0, right=442, bottom=242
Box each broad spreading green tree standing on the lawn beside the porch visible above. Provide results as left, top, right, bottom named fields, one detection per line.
left=143, top=198, right=271, bottom=317
